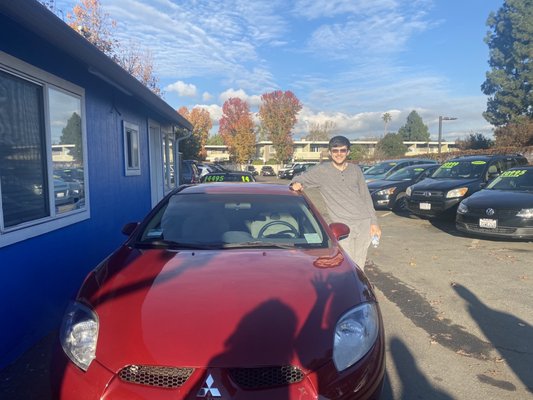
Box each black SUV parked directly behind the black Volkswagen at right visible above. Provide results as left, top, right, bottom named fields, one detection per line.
left=406, top=154, right=527, bottom=218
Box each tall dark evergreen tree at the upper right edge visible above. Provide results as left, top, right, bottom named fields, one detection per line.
left=481, top=0, right=533, bottom=126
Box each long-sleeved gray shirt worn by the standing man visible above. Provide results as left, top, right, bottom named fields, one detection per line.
left=291, top=161, right=377, bottom=225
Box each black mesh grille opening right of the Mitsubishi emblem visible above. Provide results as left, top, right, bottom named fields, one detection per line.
left=230, top=365, right=304, bottom=389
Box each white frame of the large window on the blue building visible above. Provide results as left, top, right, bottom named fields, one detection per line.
left=0, top=51, right=91, bottom=248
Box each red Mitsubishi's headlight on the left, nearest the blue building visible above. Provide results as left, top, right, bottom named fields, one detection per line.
left=59, top=302, right=99, bottom=371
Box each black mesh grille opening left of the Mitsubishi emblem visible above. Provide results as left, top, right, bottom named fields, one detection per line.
left=119, top=365, right=194, bottom=388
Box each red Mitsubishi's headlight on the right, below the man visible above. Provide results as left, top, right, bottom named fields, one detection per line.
left=333, top=303, right=379, bottom=372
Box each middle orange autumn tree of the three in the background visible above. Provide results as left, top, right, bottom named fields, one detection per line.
left=219, top=97, right=255, bottom=164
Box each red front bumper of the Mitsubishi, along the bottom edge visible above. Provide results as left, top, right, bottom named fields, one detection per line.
left=52, top=331, right=385, bottom=400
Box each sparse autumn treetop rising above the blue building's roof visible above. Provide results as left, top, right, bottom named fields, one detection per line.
left=67, top=0, right=162, bottom=96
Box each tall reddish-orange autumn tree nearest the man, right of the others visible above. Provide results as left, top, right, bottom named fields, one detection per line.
left=259, top=90, right=302, bottom=163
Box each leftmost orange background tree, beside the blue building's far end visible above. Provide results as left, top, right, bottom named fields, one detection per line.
left=178, top=107, right=213, bottom=160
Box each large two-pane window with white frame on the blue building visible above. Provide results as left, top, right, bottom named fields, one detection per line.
left=0, top=52, right=89, bottom=247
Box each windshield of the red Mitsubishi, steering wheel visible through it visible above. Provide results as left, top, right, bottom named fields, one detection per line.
left=136, top=193, right=329, bottom=249
